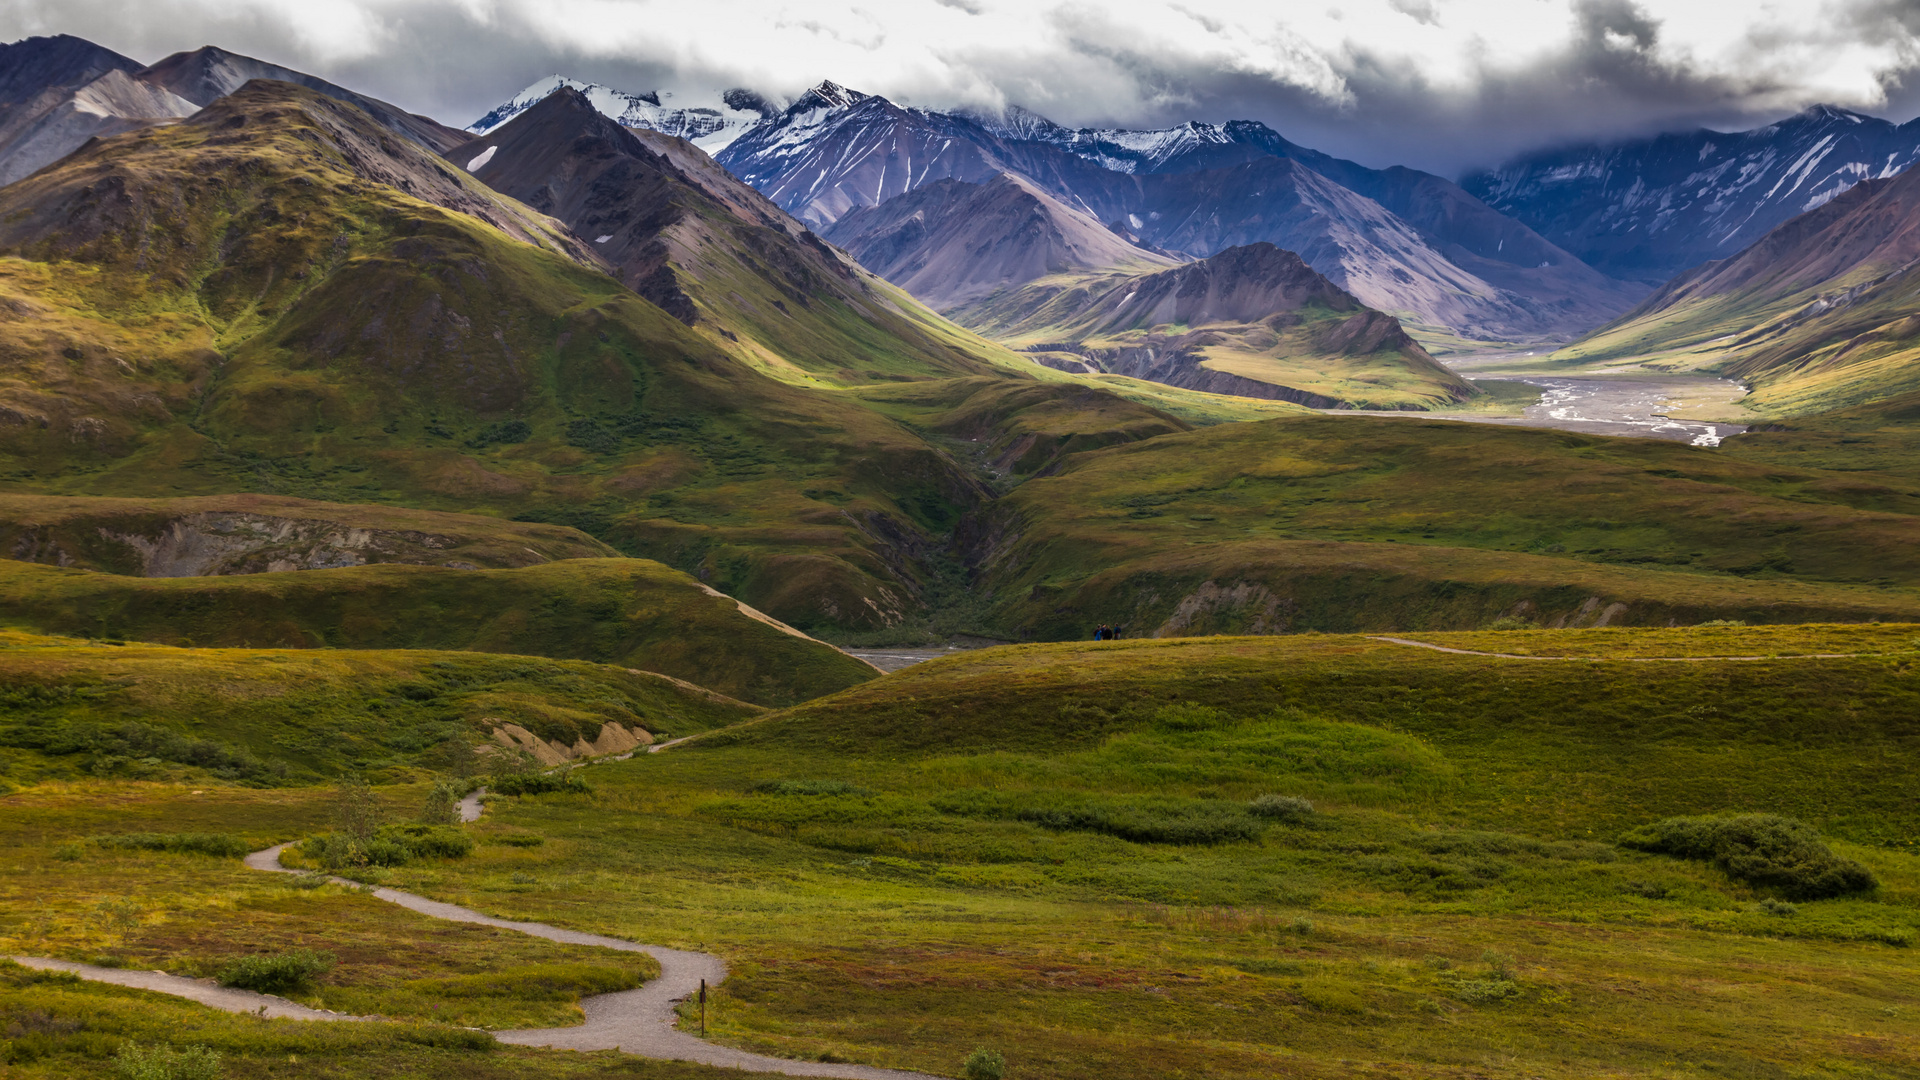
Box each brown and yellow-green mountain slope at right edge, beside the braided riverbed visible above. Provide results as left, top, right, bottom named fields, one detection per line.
left=1561, top=159, right=1920, bottom=413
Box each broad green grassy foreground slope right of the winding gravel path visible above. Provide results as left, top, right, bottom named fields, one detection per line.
left=341, top=626, right=1920, bottom=1078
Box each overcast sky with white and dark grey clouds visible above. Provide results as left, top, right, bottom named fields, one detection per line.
left=11, top=0, right=1920, bottom=175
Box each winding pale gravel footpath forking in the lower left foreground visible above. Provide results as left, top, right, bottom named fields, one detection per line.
left=12, top=792, right=941, bottom=1080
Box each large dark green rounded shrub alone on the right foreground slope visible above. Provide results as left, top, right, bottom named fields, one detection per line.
left=1620, top=813, right=1880, bottom=899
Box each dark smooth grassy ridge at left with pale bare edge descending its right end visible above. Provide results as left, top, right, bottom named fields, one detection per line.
left=0, top=559, right=876, bottom=705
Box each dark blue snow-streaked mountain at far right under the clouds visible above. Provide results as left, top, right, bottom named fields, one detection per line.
left=1463, top=106, right=1920, bottom=282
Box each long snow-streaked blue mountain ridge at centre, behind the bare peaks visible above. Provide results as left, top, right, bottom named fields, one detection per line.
left=716, top=83, right=1645, bottom=338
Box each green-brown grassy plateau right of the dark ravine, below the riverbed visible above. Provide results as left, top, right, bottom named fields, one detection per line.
left=981, top=407, right=1920, bottom=638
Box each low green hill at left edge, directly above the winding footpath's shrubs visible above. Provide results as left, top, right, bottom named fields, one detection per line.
left=0, top=634, right=756, bottom=780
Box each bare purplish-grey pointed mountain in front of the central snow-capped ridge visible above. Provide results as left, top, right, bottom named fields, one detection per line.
left=824, top=173, right=1179, bottom=315
